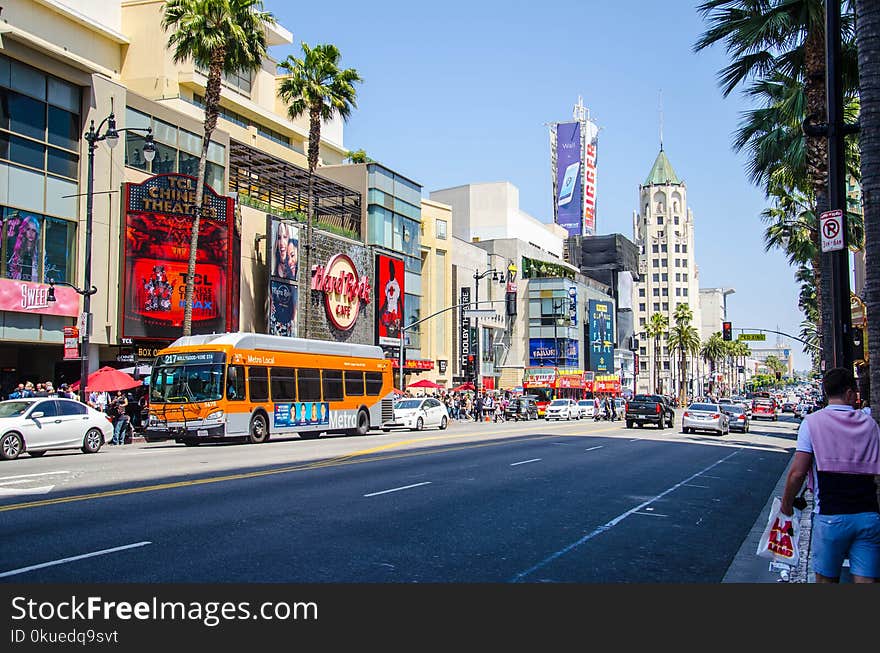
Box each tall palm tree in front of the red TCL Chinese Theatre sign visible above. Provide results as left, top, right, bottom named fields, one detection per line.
left=162, top=0, right=275, bottom=336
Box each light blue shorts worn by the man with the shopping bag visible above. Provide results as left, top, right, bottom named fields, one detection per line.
left=810, top=512, right=880, bottom=578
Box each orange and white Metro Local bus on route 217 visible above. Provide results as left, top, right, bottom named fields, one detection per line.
left=145, top=333, right=394, bottom=446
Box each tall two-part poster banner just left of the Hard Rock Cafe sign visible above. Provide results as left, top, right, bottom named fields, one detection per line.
left=266, top=215, right=299, bottom=338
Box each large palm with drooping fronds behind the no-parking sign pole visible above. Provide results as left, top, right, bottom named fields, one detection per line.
left=694, top=0, right=858, bottom=362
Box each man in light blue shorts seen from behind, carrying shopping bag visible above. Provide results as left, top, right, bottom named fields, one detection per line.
left=780, top=367, right=880, bottom=583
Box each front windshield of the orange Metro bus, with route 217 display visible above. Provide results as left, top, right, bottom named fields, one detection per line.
left=150, top=352, right=225, bottom=404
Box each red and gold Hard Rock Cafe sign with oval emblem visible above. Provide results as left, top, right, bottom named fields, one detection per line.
left=312, top=254, right=373, bottom=331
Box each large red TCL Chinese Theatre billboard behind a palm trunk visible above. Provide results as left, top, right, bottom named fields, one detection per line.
left=120, top=174, right=238, bottom=341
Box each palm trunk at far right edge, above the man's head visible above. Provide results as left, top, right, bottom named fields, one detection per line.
left=856, top=0, right=880, bottom=419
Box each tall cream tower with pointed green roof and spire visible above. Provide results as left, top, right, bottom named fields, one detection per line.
left=633, top=144, right=701, bottom=393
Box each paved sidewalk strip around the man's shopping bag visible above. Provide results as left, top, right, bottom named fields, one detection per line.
left=721, top=456, right=816, bottom=583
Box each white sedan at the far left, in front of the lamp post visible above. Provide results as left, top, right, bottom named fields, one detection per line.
left=0, top=397, right=113, bottom=460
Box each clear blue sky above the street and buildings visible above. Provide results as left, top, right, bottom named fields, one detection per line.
left=265, top=0, right=809, bottom=369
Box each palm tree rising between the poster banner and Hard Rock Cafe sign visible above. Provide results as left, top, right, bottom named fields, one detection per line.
left=278, top=42, right=366, bottom=338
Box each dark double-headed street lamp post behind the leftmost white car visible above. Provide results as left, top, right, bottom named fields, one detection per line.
left=47, top=111, right=156, bottom=403
